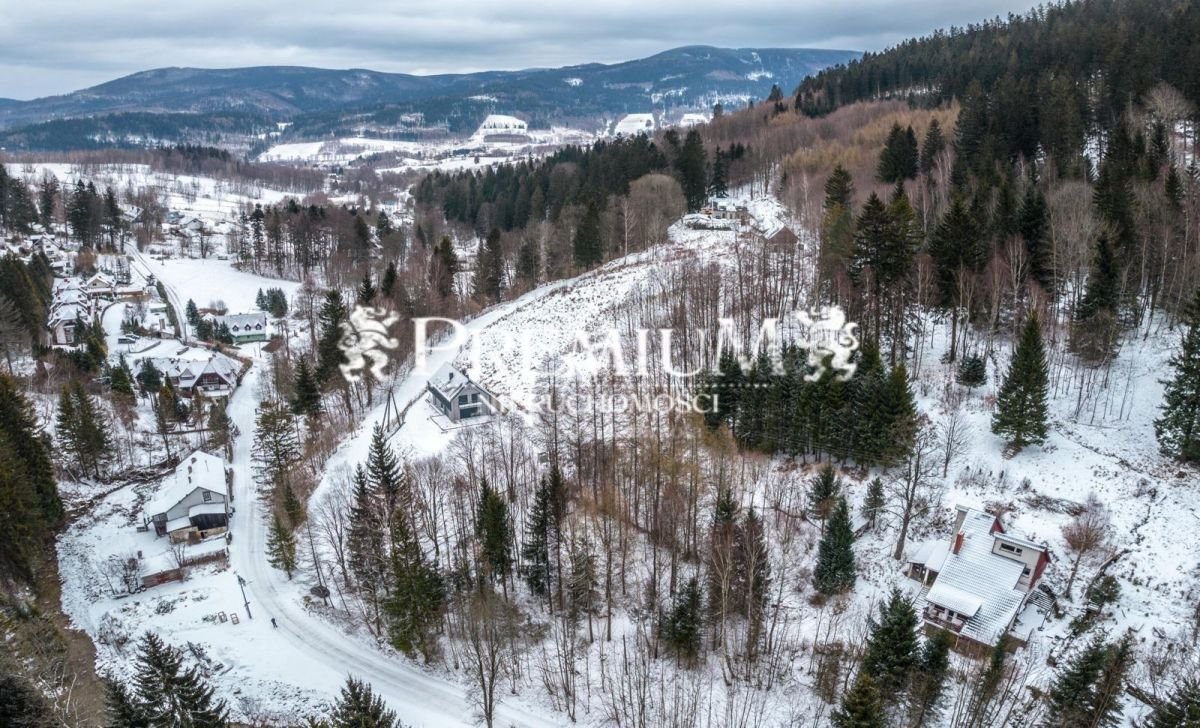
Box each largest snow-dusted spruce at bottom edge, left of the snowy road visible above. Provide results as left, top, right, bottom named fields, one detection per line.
left=133, top=632, right=229, bottom=728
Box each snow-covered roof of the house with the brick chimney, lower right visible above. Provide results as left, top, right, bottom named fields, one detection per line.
left=925, top=509, right=1026, bottom=644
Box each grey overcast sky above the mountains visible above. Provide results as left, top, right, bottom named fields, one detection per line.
left=0, top=0, right=1034, bottom=98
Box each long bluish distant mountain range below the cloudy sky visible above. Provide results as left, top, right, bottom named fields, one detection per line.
left=0, top=46, right=862, bottom=149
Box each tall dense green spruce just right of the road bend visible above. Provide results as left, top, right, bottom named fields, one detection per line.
left=384, top=513, right=445, bottom=660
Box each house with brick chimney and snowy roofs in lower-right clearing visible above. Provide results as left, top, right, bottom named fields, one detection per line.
left=906, top=506, right=1050, bottom=650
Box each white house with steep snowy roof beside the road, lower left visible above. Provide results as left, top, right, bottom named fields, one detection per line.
left=145, top=450, right=232, bottom=543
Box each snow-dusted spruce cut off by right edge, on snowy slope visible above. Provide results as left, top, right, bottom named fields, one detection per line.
left=1154, top=289, right=1200, bottom=463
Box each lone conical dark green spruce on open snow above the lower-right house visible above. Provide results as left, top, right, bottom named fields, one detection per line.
left=991, top=313, right=1049, bottom=451
